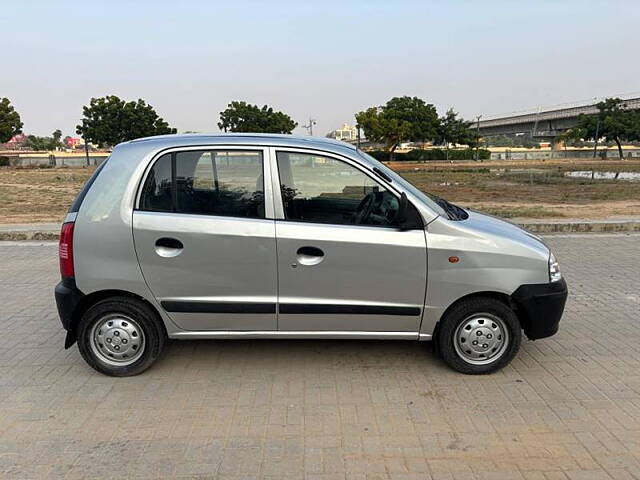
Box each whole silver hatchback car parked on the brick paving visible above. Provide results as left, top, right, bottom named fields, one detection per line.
left=55, top=134, right=567, bottom=376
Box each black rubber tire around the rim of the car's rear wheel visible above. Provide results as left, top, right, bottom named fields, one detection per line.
left=77, top=297, right=166, bottom=377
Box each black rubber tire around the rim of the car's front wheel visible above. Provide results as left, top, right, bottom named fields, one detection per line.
left=436, top=297, right=522, bottom=374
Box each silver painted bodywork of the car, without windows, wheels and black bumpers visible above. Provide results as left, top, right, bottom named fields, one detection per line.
left=74, top=134, right=549, bottom=339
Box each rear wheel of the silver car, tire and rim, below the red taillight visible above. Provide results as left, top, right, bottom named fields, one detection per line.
left=78, top=297, right=165, bottom=377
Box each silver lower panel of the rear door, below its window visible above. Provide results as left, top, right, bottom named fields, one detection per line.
left=133, top=211, right=278, bottom=330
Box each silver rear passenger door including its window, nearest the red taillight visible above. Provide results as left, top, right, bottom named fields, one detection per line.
left=133, top=147, right=277, bottom=331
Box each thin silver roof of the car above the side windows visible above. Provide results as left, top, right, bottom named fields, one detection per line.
left=124, top=133, right=356, bottom=151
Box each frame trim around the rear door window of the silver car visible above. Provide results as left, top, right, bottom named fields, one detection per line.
left=138, top=144, right=274, bottom=220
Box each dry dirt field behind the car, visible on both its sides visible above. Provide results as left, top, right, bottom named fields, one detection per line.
left=0, top=159, right=640, bottom=223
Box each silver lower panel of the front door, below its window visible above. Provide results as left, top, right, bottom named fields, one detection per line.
left=276, top=221, right=427, bottom=332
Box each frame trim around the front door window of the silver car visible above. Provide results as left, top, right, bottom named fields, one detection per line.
left=272, top=147, right=424, bottom=230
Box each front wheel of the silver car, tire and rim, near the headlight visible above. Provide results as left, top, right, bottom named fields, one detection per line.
left=437, top=297, right=522, bottom=374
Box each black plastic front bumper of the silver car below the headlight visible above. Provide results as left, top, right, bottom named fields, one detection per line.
left=511, top=278, right=569, bottom=340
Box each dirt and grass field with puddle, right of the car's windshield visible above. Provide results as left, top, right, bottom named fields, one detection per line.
left=390, top=159, right=640, bottom=219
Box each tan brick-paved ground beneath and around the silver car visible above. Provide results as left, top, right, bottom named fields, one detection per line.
left=0, top=235, right=640, bottom=480
